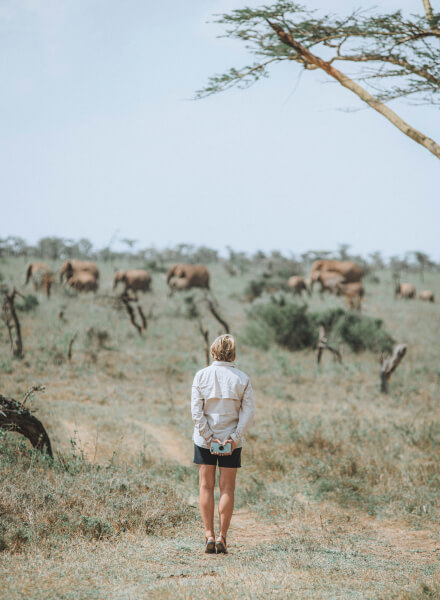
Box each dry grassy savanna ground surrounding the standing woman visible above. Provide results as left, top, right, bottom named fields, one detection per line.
left=0, top=258, right=440, bottom=600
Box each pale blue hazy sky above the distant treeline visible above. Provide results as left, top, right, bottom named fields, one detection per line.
left=0, top=0, right=440, bottom=260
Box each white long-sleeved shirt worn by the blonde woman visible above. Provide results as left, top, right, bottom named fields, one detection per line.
left=191, top=360, right=255, bottom=448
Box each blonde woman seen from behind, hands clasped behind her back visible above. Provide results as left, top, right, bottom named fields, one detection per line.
left=191, top=335, right=254, bottom=554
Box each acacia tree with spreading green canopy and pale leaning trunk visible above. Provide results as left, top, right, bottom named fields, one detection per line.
left=196, top=0, right=440, bottom=158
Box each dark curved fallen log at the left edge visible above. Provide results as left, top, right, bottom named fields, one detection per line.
left=0, top=394, right=53, bottom=457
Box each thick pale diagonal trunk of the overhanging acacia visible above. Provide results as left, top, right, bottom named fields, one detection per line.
left=267, top=20, right=440, bottom=158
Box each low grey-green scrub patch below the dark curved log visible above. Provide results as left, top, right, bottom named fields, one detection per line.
left=0, top=432, right=195, bottom=553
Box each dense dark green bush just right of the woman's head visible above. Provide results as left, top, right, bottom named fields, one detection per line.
left=245, top=296, right=394, bottom=352
